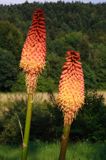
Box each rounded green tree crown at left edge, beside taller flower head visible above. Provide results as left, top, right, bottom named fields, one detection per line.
left=0, top=21, right=23, bottom=60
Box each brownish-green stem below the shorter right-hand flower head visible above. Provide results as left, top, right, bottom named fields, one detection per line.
left=59, top=124, right=71, bottom=160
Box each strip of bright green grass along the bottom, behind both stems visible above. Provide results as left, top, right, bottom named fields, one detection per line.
left=0, top=141, right=106, bottom=160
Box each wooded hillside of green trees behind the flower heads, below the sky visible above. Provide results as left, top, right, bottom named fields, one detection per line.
left=0, top=1, right=106, bottom=92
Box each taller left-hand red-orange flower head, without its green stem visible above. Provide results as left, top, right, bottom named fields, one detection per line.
left=20, top=9, right=46, bottom=93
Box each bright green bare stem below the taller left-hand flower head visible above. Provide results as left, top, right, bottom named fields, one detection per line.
left=21, top=94, right=33, bottom=160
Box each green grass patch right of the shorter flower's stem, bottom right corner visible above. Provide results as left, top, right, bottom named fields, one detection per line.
left=66, top=142, right=106, bottom=160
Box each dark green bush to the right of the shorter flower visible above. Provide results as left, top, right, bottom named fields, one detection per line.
left=72, top=92, right=106, bottom=142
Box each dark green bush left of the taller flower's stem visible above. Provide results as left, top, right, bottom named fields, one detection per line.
left=0, top=100, right=26, bottom=144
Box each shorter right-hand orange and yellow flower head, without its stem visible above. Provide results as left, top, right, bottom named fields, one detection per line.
left=57, top=50, right=84, bottom=125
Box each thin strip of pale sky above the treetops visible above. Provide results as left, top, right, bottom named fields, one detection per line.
left=0, top=0, right=106, bottom=4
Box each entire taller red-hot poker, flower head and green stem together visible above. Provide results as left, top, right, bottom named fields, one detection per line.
left=20, top=9, right=46, bottom=160
